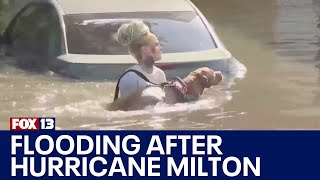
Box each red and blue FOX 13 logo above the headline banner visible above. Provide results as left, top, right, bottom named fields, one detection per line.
left=10, top=117, right=56, bottom=131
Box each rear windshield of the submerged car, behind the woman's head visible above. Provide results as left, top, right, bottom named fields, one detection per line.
left=64, top=12, right=216, bottom=55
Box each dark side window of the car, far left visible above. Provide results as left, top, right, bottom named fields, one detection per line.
left=6, top=5, right=61, bottom=56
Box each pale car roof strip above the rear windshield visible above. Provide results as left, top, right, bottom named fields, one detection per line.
left=56, top=0, right=194, bottom=14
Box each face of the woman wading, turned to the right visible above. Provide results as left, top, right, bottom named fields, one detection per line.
left=143, top=34, right=162, bottom=61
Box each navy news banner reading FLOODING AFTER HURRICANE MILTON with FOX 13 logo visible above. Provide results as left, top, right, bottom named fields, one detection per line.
left=0, top=117, right=320, bottom=180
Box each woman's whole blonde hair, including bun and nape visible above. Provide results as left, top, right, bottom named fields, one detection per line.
left=118, top=20, right=152, bottom=61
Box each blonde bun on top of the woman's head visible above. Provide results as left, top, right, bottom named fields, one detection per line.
left=118, top=21, right=150, bottom=46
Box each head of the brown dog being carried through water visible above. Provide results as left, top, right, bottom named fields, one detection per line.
left=183, top=67, right=223, bottom=97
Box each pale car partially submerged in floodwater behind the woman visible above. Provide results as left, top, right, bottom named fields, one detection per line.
left=1, top=0, right=246, bottom=80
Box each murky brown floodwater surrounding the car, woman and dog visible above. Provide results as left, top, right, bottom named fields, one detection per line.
left=0, top=0, right=320, bottom=129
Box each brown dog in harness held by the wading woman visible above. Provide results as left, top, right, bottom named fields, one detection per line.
left=107, top=67, right=223, bottom=111
